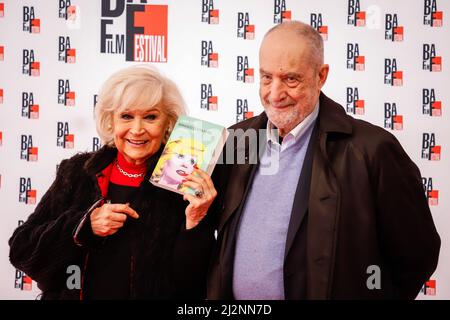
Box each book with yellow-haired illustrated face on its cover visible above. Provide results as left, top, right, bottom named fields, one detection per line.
left=150, top=115, right=229, bottom=195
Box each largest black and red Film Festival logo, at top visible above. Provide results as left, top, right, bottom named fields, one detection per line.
left=100, top=0, right=168, bottom=62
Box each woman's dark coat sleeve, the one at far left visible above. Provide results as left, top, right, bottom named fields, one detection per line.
left=9, top=160, right=90, bottom=290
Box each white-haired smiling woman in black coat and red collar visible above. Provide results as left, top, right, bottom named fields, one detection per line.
left=9, top=66, right=216, bottom=299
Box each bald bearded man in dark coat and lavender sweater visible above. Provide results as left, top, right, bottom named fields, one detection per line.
left=208, top=21, right=440, bottom=300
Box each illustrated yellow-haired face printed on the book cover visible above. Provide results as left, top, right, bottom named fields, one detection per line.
left=153, top=139, right=205, bottom=191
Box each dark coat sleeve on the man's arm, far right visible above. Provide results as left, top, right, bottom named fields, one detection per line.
left=372, top=136, right=440, bottom=299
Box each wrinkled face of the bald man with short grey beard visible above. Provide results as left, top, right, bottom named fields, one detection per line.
left=259, top=29, right=328, bottom=136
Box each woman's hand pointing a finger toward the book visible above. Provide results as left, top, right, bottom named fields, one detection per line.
left=90, top=203, right=139, bottom=237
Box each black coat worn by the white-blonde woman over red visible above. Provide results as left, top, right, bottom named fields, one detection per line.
left=9, top=147, right=214, bottom=299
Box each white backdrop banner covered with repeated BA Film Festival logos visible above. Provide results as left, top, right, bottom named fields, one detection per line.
left=0, top=0, right=450, bottom=299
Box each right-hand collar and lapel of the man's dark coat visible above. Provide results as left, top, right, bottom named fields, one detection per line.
left=306, top=94, right=352, bottom=299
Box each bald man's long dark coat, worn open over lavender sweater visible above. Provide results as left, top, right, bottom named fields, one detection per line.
left=208, top=94, right=440, bottom=299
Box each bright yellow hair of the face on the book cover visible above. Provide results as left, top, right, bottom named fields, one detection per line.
left=151, top=138, right=206, bottom=189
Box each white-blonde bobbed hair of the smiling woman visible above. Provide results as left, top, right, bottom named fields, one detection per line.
left=95, top=65, right=186, bottom=146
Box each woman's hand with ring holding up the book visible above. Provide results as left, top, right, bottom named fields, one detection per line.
left=183, top=168, right=217, bottom=229
